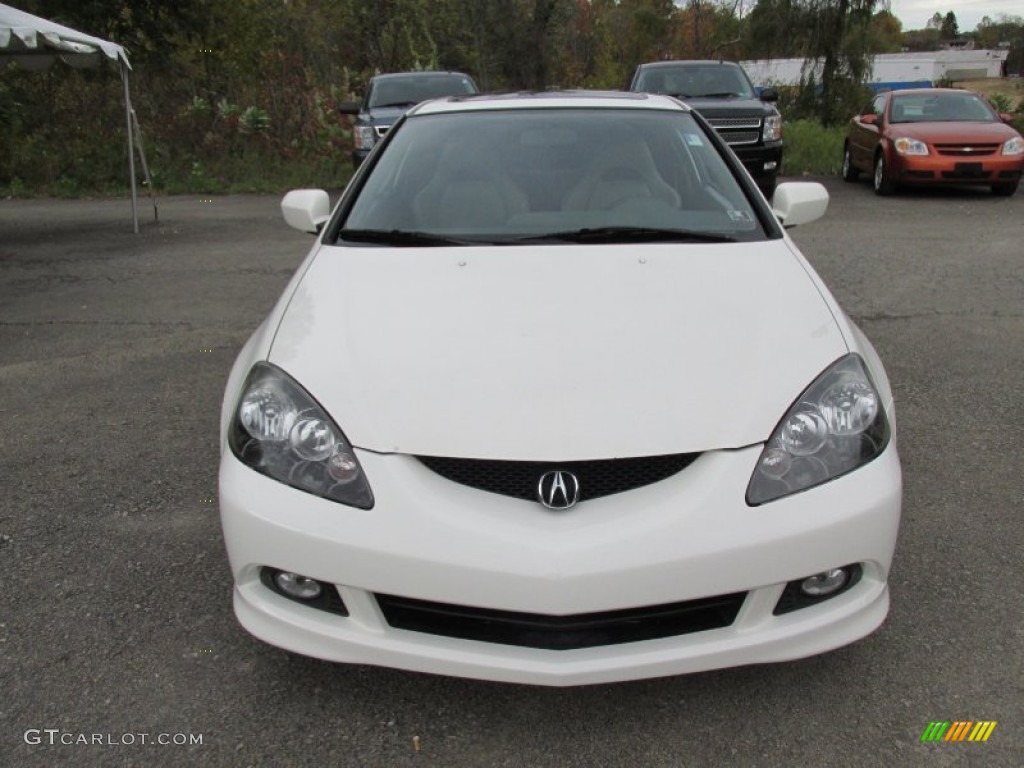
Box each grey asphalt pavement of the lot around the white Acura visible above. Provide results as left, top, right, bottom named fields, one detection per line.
left=0, top=179, right=1024, bottom=768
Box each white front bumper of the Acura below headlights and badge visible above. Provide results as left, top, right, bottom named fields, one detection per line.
left=220, top=445, right=900, bottom=685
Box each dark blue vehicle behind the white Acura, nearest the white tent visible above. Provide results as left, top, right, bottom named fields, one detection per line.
left=338, top=72, right=479, bottom=168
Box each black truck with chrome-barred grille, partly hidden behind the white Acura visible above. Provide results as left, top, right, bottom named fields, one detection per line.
left=629, top=61, right=782, bottom=198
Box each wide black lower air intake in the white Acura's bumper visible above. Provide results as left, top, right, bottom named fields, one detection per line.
left=377, top=592, right=746, bottom=650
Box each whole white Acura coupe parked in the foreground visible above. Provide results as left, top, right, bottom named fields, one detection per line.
left=220, top=92, right=901, bottom=685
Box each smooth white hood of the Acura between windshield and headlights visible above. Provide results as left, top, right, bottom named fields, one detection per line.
left=268, top=240, right=847, bottom=461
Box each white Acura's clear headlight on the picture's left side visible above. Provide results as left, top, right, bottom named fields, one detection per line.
left=227, top=362, right=374, bottom=509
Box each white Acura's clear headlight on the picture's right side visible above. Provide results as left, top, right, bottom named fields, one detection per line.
left=746, top=354, right=889, bottom=507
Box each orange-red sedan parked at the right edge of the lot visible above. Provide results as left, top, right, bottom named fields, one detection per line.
left=843, top=88, right=1024, bottom=196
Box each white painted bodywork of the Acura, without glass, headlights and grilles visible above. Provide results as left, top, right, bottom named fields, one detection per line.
left=219, top=90, right=901, bottom=686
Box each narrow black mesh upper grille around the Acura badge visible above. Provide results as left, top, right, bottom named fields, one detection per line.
left=418, top=454, right=699, bottom=502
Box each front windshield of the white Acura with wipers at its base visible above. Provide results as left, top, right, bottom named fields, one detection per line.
left=339, top=109, right=766, bottom=246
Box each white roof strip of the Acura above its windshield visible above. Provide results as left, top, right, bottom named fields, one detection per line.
left=409, top=90, right=690, bottom=117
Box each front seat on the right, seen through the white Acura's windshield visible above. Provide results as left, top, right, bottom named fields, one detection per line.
left=562, top=137, right=680, bottom=211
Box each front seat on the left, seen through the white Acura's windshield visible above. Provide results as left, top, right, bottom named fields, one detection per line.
left=413, top=142, right=529, bottom=230
